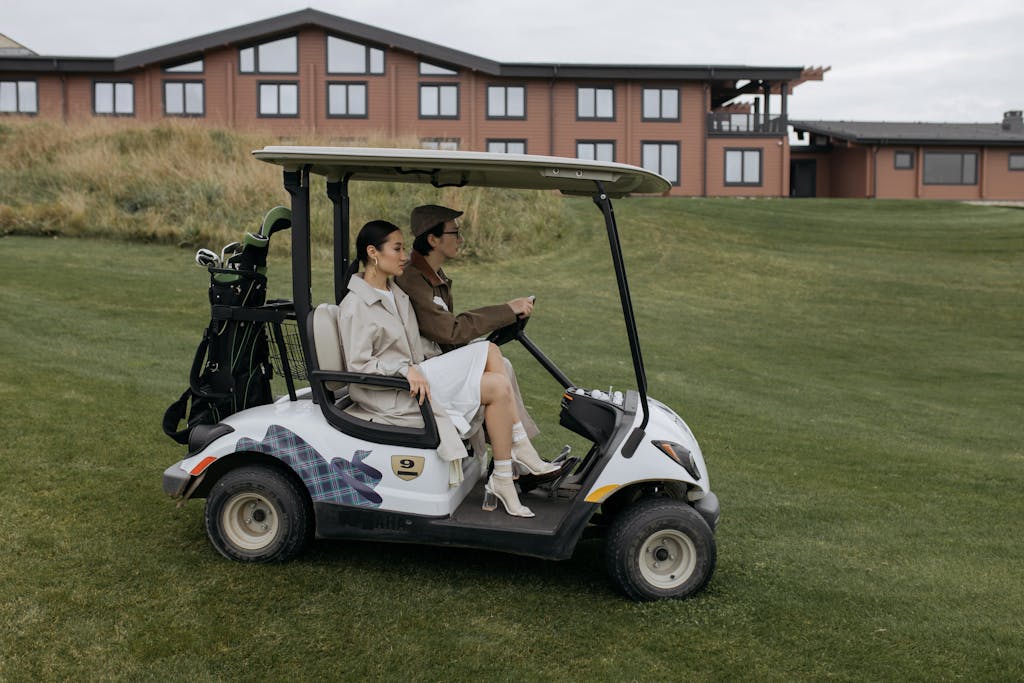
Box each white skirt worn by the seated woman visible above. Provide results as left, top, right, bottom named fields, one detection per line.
left=419, top=341, right=487, bottom=436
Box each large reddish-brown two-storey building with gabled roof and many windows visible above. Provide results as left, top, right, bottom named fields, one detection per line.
left=0, top=9, right=826, bottom=197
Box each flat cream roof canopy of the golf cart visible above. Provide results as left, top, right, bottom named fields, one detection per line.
left=253, top=145, right=671, bottom=197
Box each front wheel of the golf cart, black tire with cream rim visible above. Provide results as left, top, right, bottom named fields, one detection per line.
left=604, top=498, right=718, bottom=601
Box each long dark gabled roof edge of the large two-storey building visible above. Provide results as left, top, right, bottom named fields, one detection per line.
left=0, top=9, right=822, bottom=94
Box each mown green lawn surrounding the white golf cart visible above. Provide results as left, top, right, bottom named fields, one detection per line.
left=0, top=199, right=1024, bottom=681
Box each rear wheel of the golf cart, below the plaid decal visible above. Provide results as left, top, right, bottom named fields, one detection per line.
left=206, top=466, right=312, bottom=562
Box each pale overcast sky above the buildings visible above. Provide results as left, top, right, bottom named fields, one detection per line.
left=0, top=0, right=1024, bottom=123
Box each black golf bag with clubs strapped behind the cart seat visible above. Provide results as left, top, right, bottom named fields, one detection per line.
left=163, top=207, right=291, bottom=443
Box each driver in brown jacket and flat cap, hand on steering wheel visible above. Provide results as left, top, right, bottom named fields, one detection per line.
left=395, top=204, right=559, bottom=475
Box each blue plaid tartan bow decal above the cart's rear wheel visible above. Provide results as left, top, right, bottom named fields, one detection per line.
left=234, top=425, right=383, bottom=508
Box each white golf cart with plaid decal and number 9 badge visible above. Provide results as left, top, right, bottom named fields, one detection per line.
left=164, top=146, right=719, bottom=600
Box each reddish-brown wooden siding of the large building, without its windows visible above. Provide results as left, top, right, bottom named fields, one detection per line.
left=5, top=27, right=806, bottom=197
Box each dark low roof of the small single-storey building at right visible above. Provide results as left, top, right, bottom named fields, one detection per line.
left=790, top=121, right=1024, bottom=145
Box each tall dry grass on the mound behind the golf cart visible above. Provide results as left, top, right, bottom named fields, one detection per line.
left=0, top=121, right=562, bottom=259
